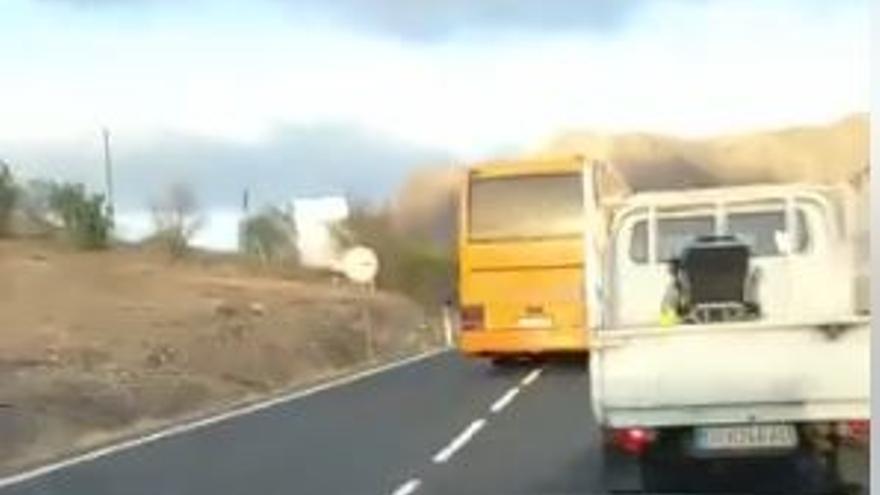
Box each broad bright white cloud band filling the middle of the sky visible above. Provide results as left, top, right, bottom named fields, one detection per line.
left=10, top=0, right=870, bottom=178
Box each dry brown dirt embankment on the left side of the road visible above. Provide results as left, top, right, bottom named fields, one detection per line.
left=0, top=241, right=439, bottom=473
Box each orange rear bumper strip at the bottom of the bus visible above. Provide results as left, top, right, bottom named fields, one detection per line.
left=458, top=329, right=587, bottom=357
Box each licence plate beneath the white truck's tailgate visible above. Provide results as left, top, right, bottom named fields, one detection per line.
left=695, top=425, right=797, bottom=450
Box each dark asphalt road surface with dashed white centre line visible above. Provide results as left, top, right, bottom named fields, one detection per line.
left=0, top=352, right=599, bottom=495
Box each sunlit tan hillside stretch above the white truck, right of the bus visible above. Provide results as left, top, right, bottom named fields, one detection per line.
left=534, top=114, right=870, bottom=189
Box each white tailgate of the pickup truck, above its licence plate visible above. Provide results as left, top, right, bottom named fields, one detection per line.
left=591, top=319, right=870, bottom=426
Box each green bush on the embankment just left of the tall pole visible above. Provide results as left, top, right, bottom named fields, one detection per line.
left=49, top=183, right=113, bottom=249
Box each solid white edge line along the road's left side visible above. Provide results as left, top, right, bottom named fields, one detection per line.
left=0, top=348, right=450, bottom=488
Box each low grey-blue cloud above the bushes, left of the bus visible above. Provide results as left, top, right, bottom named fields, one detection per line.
left=0, top=126, right=449, bottom=209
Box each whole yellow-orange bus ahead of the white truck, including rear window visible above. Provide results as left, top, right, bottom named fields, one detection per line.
left=458, top=156, right=622, bottom=363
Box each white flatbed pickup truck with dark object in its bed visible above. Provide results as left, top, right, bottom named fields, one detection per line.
left=585, top=184, right=870, bottom=493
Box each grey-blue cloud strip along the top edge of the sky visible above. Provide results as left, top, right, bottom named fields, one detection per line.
left=33, top=0, right=868, bottom=41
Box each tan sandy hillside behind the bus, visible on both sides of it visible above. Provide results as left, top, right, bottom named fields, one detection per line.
left=393, top=114, right=870, bottom=244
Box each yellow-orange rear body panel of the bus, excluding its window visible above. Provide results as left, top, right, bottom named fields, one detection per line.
left=458, top=157, right=589, bottom=357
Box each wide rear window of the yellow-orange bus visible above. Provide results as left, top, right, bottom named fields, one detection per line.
left=468, top=174, right=583, bottom=241
